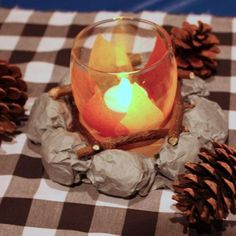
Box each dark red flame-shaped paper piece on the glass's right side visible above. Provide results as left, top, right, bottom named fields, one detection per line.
left=139, top=35, right=177, bottom=119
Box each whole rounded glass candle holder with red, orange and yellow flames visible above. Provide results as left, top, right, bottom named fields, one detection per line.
left=70, top=17, right=177, bottom=138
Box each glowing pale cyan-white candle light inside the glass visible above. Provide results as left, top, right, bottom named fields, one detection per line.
left=104, top=78, right=133, bottom=113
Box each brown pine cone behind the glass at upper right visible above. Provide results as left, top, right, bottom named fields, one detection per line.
left=171, top=21, right=220, bottom=78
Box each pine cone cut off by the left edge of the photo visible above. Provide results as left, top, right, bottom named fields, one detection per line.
left=0, top=60, right=28, bottom=143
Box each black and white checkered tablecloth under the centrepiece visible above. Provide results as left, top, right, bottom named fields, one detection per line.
left=0, top=6, right=236, bottom=236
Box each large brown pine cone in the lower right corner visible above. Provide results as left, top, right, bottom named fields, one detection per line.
left=173, top=143, right=236, bottom=223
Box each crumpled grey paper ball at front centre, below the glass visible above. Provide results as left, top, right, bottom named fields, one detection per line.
left=87, top=149, right=156, bottom=197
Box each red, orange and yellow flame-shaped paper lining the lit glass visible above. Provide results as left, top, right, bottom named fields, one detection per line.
left=71, top=32, right=176, bottom=137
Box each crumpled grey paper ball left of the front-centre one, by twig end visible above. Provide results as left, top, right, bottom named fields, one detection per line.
left=41, top=128, right=91, bottom=185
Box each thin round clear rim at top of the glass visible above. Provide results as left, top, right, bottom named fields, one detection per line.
left=71, top=16, right=173, bottom=76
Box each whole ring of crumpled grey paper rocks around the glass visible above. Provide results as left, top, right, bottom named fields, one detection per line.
left=27, top=78, right=228, bottom=197
